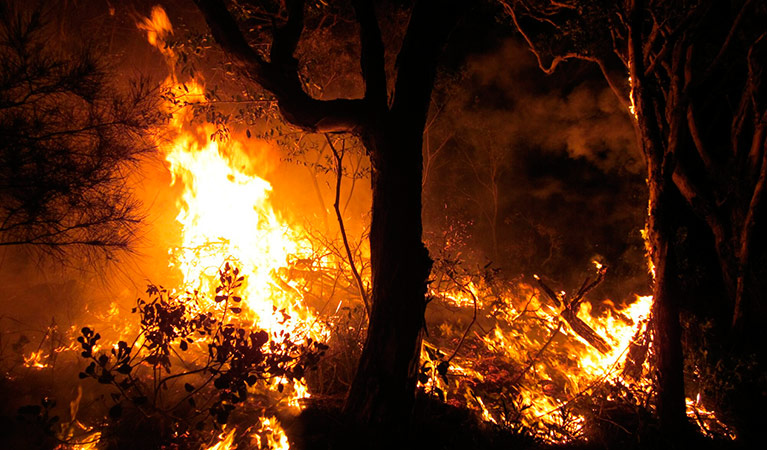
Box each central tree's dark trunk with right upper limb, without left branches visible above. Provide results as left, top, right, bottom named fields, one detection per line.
left=344, top=2, right=457, bottom=428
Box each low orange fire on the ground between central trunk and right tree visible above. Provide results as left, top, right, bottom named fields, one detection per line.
left=423, top=265, right=652, bottom=442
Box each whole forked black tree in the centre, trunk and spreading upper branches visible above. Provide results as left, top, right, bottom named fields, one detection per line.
left=196, top=0, right=457, bottom=435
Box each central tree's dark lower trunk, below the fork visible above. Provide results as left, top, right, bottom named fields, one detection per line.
left=345, top=124, right=432, bottom=432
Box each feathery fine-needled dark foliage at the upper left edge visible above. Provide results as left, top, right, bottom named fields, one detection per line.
left=0, top=2, right=161, bottom=256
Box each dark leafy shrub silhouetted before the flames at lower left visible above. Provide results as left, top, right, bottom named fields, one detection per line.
left=77, top=262, right=328, bottom=445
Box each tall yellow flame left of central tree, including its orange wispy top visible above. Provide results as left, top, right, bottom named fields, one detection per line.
left=138, top=6, right=328, bottom=418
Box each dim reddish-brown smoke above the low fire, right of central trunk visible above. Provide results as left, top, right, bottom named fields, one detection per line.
left=424, top=39, right=647, bottom=297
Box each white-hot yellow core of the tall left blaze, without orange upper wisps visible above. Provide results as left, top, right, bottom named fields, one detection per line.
left=166, top=113, right=319, bottom=337
